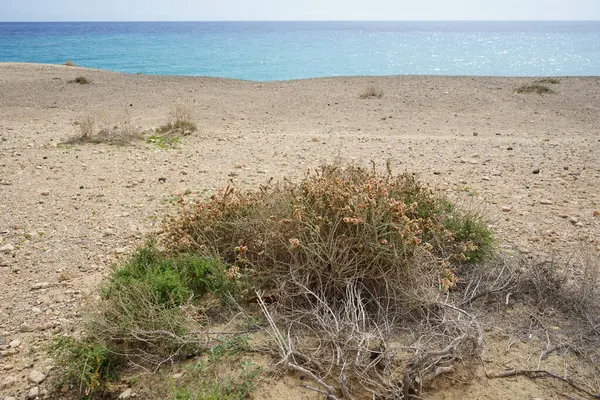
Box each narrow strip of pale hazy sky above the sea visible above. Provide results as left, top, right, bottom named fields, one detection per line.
left=0, top=0, right=600, bottom=21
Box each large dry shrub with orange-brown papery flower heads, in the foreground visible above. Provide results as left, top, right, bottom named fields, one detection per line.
left=166, top=166, right=492, bottom=310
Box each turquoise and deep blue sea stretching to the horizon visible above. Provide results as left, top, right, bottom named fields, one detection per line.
left=0, top=21, right=600, bottom=81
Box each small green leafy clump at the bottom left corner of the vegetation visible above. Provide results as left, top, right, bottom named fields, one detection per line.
left=48, top=336, right=120, bottom=396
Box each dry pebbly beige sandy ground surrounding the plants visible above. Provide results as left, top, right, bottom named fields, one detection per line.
left=0, top=63, right=600, bottom=399
